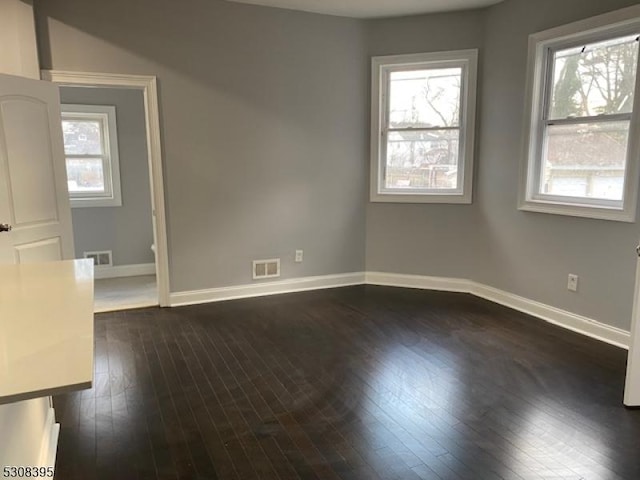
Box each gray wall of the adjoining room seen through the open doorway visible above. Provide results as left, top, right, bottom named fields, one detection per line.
left=60, top=87, right=155, bottom=265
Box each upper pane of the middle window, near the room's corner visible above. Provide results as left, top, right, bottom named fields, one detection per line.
left=389, top=68, right=462, bottom=128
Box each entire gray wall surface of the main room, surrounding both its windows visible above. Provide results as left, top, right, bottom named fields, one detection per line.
left=36, top=0, right=640, bottom=329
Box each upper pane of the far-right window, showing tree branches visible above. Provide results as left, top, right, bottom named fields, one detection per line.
left=550, top=35, right=638, bottom=119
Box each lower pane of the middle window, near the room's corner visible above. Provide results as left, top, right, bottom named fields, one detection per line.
left=385, top=130, right=460, bottom=189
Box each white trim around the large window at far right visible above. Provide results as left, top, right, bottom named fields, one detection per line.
left=518, top=5, right=640, bottom=222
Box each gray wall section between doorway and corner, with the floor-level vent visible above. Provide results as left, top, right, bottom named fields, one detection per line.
left=36, top=0, right=368, bottom=292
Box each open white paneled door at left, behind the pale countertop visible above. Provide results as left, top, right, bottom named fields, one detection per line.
left=0, top=75, right=74, bottom=264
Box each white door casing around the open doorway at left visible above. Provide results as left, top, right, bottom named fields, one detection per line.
left=40, top=70, right=170, bottom=307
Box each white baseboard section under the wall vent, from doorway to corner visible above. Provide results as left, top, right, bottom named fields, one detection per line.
left=169, top=272, right=365, bottom=307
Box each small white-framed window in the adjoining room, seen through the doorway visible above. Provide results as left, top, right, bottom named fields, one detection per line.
left=62, top=105, right=122, bottom=207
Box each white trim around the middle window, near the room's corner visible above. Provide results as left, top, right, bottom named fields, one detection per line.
left=370, top=49, right=478, bottom=204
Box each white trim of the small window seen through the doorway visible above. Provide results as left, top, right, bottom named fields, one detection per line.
left=61, top=104, right=122, bottom=208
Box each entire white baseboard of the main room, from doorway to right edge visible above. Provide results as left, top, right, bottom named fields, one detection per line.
left=170, top=272, right=631, bottom=349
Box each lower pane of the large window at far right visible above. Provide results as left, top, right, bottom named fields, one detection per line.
left=541, top=121, right=629, bottom=200
